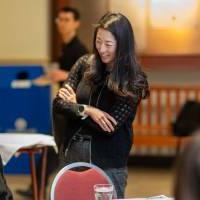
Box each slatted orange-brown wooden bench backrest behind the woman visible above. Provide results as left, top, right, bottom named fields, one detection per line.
left=134, top=84, right=200, bottom=136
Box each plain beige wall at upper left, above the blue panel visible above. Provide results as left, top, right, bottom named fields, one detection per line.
left=0, top=0, right=49, bottom=62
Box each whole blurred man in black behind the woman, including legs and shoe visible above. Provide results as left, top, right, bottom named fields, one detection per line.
left=17, top=7, right=88, bottom=197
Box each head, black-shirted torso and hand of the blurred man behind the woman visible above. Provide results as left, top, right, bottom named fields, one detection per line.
left=49, top=7, right=88, bottom=83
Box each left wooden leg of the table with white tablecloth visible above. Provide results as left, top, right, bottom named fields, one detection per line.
left=29, top=152, right=38, bottom=200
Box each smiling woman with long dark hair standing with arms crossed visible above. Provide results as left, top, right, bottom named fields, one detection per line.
left=53, top=13, right=149, bottom=198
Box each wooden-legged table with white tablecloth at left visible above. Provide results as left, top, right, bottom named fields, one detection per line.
left=0, top=133, right=56, bottom=200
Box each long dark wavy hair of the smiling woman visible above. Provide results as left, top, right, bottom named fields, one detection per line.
left=85, top=13, right=149, bottom=98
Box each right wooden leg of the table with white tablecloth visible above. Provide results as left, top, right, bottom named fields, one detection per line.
left=39, top=147, right=47, bottom=200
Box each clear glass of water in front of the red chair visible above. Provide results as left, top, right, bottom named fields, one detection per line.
left=94, top=184, right=113, bottom=200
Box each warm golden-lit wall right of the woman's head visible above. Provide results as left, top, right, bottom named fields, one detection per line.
left=109, top=0, right=200, bottom=55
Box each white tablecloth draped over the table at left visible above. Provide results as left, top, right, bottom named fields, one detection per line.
left=0, top=133, right=56, bottom=165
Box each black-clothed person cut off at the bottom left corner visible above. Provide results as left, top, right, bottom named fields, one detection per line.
left=0, top=156, right=13, bottom=200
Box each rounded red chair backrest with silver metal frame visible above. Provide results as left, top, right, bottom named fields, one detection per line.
left=51, top=162, right=116, bottom=200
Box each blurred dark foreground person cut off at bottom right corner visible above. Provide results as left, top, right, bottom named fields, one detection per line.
left=174, top=130, right=200, bottom=200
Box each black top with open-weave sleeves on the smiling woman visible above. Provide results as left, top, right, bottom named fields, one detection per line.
left=53, top=55, right=139, bottom=169
